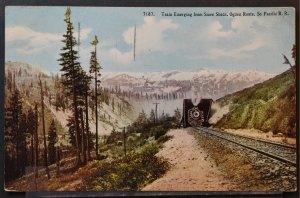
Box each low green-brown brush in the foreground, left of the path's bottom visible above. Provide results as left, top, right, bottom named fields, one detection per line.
left=79, top=143, right=169, bottom=191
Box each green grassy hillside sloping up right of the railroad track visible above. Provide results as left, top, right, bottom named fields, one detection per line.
left=215, top=67, right=296, bottom=137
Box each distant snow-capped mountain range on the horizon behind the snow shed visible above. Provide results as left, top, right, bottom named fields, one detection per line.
left=102, top=69, right=274, bottom=100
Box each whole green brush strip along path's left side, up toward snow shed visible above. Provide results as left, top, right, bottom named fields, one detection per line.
left=78, top=111, right=176, bottom=191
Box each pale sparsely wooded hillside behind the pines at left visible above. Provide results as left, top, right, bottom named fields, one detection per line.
left=5, top=61, right=132, bottom=143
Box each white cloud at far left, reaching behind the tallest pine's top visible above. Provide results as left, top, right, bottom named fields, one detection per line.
left=5, top=26, right=92, bottom=54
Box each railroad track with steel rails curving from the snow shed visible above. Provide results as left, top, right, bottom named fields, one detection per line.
left=197, top=127, right=297, bottom=167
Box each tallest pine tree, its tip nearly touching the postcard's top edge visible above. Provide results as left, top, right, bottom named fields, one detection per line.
left=59, top=7, right=82, bottom=166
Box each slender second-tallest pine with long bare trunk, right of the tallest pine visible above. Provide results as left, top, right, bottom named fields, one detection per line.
left=90, top=36, right=101, bottom=158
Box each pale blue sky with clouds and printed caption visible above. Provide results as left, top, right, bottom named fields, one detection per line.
left=5, top=6, right=295, bottom=73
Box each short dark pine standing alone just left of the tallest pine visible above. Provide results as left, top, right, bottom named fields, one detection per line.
left=48, top=120, right=58, bottom=164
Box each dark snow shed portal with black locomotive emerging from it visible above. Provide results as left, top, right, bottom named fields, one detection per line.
left=180, top=99, right=213, bottom=128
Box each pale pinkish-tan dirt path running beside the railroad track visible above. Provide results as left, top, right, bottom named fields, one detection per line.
left=143, top=129, right=235, bottom=191
